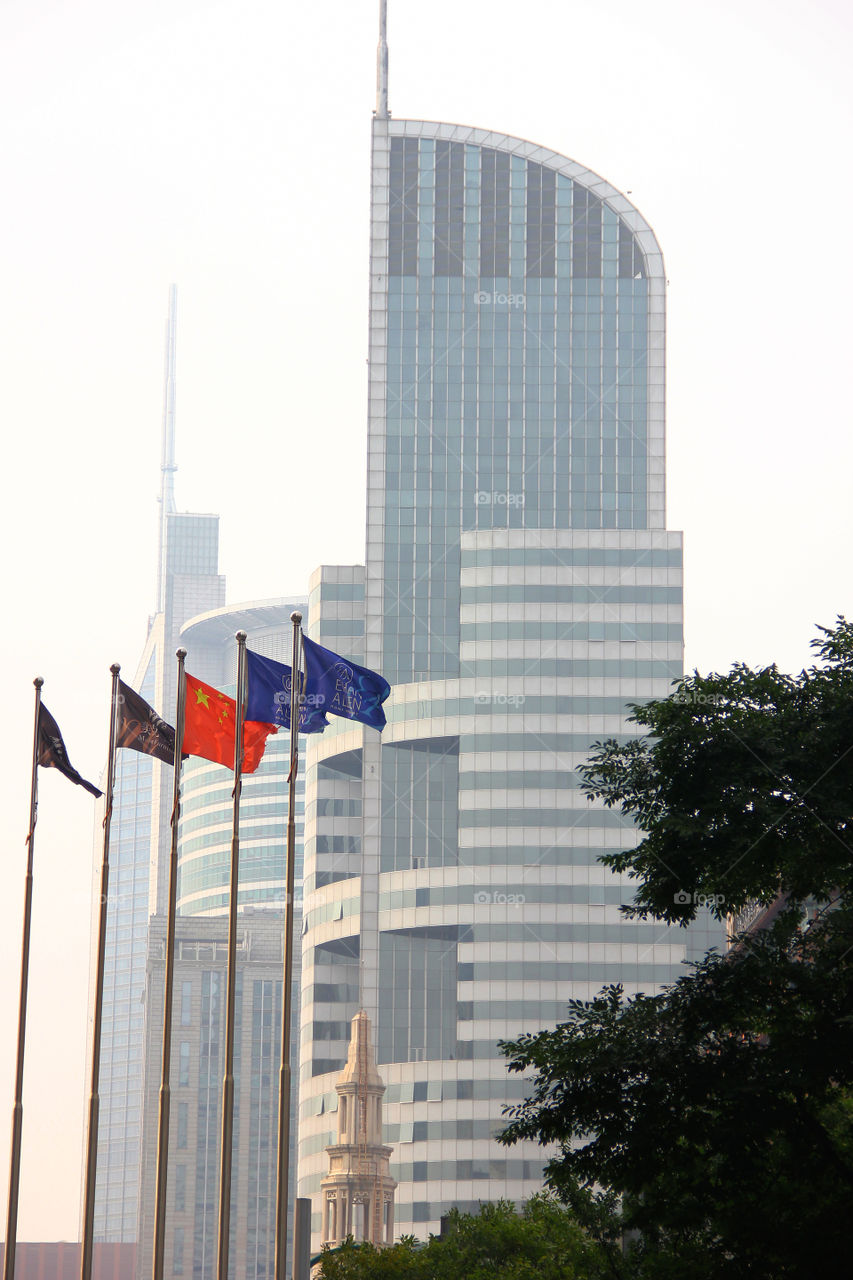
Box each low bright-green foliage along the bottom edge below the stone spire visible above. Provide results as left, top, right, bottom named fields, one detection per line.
left=312, top=1196, right=620, bottom=1280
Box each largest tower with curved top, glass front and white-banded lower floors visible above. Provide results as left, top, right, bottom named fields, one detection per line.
left=294, top=5, right=716, bottom=1245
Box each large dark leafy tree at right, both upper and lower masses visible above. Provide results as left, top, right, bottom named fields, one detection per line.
left=502, top=618, right=853, bottom=1280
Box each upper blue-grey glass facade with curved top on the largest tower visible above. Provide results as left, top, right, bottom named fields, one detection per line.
left=371, top=122, right=663, bottom=682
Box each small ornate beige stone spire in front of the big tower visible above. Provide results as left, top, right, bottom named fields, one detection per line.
left=320, top=1010, right=397, bottom=1244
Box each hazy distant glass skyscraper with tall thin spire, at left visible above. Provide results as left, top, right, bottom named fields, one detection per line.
left=87, top=285, right=225, bottom=1243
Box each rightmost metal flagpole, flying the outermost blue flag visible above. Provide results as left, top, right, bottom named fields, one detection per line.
left=275, top=612, right=302, bottom=1280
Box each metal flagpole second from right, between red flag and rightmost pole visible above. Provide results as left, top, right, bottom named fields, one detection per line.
left=216, top=631, right=246, bottom=1280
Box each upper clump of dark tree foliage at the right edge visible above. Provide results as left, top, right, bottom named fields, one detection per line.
left=580, top=618, right=853, bottom=922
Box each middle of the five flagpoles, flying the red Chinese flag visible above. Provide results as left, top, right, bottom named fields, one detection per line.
left=152, top=649, right=187, bottom=1280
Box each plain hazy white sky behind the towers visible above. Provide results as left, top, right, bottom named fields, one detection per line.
left=0, top=0, right=853, bottom=1240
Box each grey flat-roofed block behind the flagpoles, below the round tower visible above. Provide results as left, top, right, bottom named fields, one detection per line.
left=136, top=908, right=292, bottom=1280
